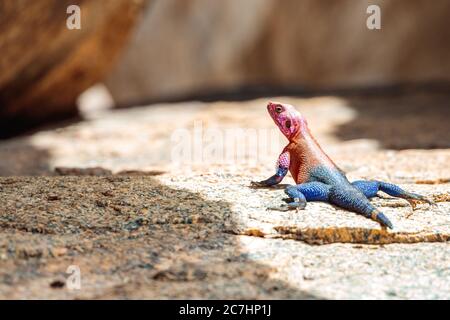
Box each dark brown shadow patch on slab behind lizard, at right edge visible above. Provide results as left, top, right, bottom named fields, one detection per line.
left=334, top=93, right=450, bottom=150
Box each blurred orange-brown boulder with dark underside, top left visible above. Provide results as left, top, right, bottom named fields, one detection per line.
left=0, top=0, right=145, bottom=135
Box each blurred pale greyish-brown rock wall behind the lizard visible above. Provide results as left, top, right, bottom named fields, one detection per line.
left=107, top=0, right=450, bottom=105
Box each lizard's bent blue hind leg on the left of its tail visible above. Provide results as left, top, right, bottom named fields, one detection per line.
left=268, top=182, right=330, bottom=211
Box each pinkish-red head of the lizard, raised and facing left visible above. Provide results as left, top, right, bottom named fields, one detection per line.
left=267, top=102, right=306, bottom=140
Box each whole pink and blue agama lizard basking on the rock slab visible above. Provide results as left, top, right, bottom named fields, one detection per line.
left=252, top=102, right=433, bottom=229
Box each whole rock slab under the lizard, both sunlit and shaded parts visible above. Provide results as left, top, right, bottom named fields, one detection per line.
left=0, top=92, right=450, bottom=299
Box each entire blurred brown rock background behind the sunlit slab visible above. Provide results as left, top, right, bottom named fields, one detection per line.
left=0, top=0, right=450, bottom=136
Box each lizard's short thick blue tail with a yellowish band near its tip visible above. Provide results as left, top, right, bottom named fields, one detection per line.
left=329, top=187, right=394, bottom=229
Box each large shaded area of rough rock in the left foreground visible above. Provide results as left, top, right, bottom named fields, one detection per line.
left=0, top=176, right=314, bottom=299
